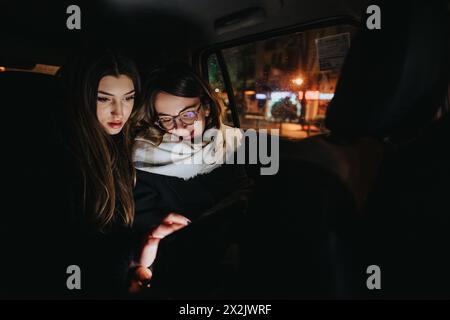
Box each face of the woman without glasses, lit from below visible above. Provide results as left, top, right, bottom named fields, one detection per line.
left=97, top=75, right=134, bottom=135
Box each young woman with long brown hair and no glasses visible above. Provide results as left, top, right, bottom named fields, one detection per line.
left=62, top=50, right=140, bottom=296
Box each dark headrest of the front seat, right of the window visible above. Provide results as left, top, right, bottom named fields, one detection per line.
left=326, top=0, right=450, bottom=138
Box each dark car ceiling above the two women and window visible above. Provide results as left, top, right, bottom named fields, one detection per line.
left=0, top=0, right=367, bottom=65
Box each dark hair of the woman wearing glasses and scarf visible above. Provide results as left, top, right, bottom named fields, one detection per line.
left=132, top=63, right=223, bottom=145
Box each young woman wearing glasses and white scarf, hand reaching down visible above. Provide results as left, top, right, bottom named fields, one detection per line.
left=127, top=64, right=251, bottom=291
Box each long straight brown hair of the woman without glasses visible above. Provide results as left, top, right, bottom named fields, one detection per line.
left=62, top=50, right=140, bottom=231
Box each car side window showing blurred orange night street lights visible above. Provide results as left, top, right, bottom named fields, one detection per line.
left=206, top=25, right=356, bottom=139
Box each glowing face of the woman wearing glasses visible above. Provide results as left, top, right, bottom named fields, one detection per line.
left=155, top=92, right=210, bottom=140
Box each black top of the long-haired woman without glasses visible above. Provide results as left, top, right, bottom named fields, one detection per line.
left=59, top=147, right=135, bottom=298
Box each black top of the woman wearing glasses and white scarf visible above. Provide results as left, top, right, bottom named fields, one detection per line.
left=134, top=164, right=252, bottom=232
